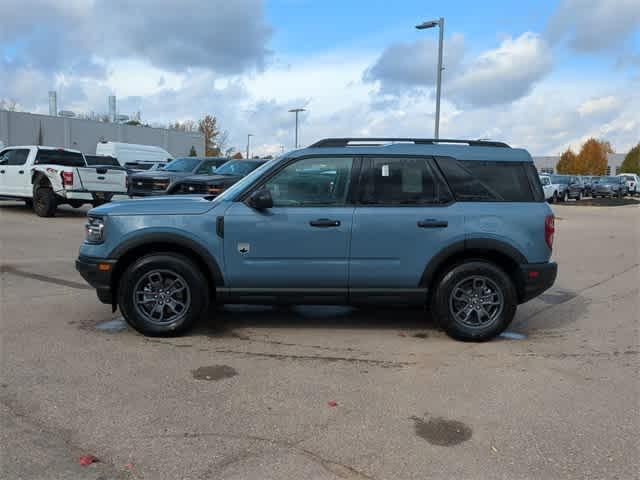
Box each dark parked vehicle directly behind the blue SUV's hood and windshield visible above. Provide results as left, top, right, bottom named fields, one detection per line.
left=171, top=160, right=266, bottom=195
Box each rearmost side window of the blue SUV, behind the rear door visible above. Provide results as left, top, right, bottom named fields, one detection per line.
left=436, top=158, right=544, bottom=202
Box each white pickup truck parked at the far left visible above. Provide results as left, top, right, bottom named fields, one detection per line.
left=0, top=146, right=127, bottom=217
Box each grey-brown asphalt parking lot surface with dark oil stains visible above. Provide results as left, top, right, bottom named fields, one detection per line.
left=0, top=202, right=640, bottom=480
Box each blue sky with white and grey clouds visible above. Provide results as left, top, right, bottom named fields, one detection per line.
left=0, top=0, right=640, bottom=155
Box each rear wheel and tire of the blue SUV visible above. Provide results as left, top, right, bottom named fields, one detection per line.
left=431, top=260, right=518, bottom=342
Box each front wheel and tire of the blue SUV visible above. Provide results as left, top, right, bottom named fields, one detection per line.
left=118, top=253, right=209, bottom=336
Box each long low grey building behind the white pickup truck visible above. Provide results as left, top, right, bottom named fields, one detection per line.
left=0, top=110, right=204, bottom=157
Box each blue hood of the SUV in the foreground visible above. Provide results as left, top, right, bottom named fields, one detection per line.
left=89, top=195, right=215, bottom=216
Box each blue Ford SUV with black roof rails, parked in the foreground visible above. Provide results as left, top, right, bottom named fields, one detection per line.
left=76, top=138, right=557, bottom=341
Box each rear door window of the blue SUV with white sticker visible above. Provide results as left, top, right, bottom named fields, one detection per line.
left=360, top=157, right=451, bottom=205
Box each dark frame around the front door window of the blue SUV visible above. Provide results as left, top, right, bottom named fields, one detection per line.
left=238, top=153, right=362, bottom=208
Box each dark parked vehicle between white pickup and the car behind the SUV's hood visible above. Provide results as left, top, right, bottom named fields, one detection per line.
left=129, top=157, right=229, bottom=197
